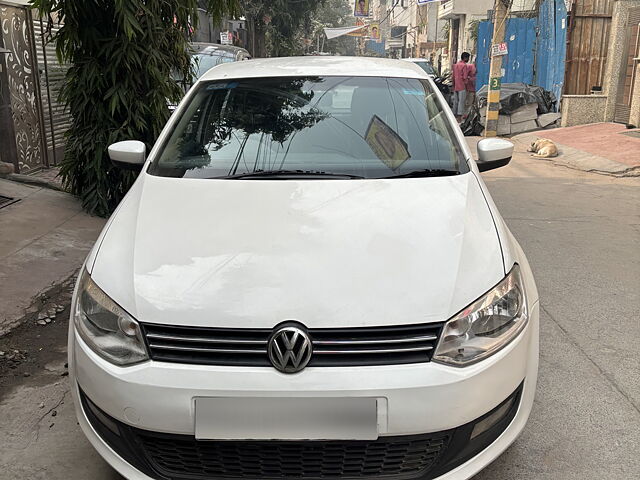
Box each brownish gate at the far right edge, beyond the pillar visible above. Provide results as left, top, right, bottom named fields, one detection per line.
left=614, top=8, right=640, bottom=123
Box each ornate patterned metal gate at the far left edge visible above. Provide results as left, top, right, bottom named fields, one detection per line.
left=0, top=4, right=47, bottom=173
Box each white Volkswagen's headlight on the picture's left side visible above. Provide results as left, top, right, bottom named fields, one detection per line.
left=74, top=269, right=149, bottom=365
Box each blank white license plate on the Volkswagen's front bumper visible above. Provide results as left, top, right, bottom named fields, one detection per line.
left=195, top=397, right=378, bottom=440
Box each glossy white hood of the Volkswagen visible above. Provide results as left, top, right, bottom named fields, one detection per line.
left=88, top=173, right=504, bottom=328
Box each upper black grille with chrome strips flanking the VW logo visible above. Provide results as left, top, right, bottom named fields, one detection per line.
left=142, top=323, right=443, bottom=367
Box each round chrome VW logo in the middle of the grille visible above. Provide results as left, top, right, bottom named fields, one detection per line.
left=267, top=325, right=313, bottom=373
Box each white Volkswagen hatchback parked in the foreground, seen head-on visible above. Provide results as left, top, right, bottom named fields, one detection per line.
left=69, top=57, right=539, bottom=479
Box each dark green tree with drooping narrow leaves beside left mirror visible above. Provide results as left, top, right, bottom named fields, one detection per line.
left=31, top=0, right=237, bottom=216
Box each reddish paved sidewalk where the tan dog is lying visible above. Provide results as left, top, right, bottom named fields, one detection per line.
left=510, top=123, right=640, bottom=177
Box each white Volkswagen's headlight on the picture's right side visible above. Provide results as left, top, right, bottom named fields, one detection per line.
left=433, top=265, right=528, bottom=367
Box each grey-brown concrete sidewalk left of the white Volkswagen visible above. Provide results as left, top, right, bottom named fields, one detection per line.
left=0, top=179, right=105, bottom=335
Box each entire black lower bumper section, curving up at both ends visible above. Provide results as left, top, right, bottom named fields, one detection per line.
left=79, top=382, right=524, bottom=480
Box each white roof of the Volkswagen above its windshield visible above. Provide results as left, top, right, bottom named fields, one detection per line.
left=200, top=56, right=429, bottom=81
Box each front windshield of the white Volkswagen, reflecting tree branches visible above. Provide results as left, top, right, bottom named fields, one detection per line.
left=149, top=77, right=468, bottom=178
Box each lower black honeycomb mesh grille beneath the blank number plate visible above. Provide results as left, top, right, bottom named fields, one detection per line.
left=138, top=431, right=450, bottom=479
